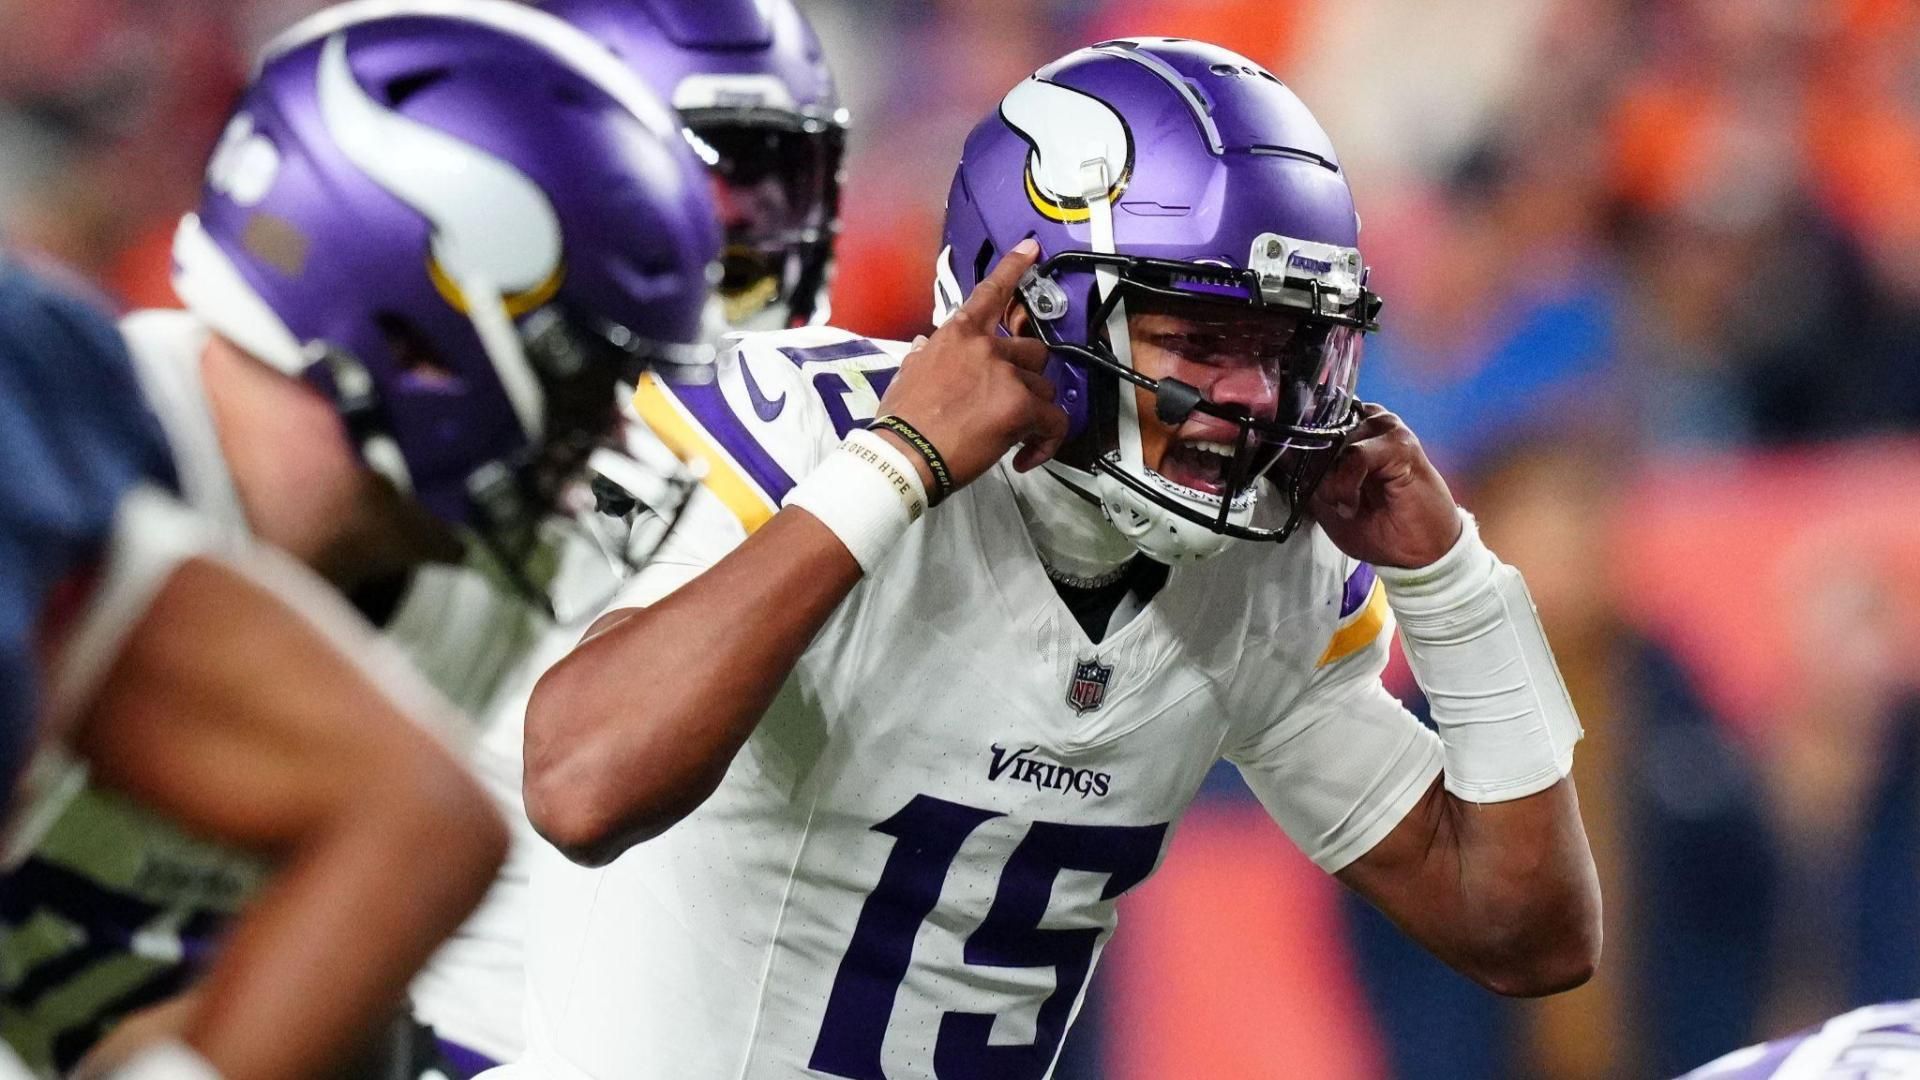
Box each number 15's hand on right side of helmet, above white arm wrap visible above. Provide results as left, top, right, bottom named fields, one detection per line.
left=1311, top=402, right=1461, bottom=569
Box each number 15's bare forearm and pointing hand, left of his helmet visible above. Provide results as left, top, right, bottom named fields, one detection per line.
left=524, top=242, right=1066, bottom=865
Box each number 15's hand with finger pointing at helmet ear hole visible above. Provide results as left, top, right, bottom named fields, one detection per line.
left=879, top=238, right=1068, bottom=488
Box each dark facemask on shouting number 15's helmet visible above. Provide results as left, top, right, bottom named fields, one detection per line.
left=1021, top=236, right=1380, bottom=561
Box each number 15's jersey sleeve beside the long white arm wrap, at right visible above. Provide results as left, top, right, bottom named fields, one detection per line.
left=1223, top=561, right=1440, bottom=872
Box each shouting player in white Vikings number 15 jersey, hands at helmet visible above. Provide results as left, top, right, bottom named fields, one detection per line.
left=503, top=38, right=1599, bottom=1080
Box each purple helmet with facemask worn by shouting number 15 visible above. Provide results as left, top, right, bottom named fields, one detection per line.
left=935, top=38, right=1380, bottom=561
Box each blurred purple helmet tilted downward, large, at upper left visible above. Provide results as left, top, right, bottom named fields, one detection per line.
left=175, top=0, right=720, bottom=588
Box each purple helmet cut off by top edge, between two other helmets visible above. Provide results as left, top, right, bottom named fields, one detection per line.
left=541, top=0, right=847, bottom=331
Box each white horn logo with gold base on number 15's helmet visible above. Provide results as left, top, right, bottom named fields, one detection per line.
left=1000, top=79, right=1133, bottom=221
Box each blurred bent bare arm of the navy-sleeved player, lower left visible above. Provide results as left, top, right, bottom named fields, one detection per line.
left=54, top=511, right=505, bottom=1078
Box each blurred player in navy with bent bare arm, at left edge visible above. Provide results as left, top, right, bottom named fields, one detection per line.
left=0, top=259, right=503, bottom=1078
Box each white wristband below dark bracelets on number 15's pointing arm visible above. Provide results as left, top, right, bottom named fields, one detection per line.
left=781, top=429, right=927, bottom=573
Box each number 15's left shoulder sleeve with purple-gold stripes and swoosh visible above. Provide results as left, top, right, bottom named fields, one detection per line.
left=612, top=327, right=906, bottom=609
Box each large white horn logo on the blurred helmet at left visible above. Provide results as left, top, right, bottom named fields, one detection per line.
left=319, top=35, right=564, bottom=315
